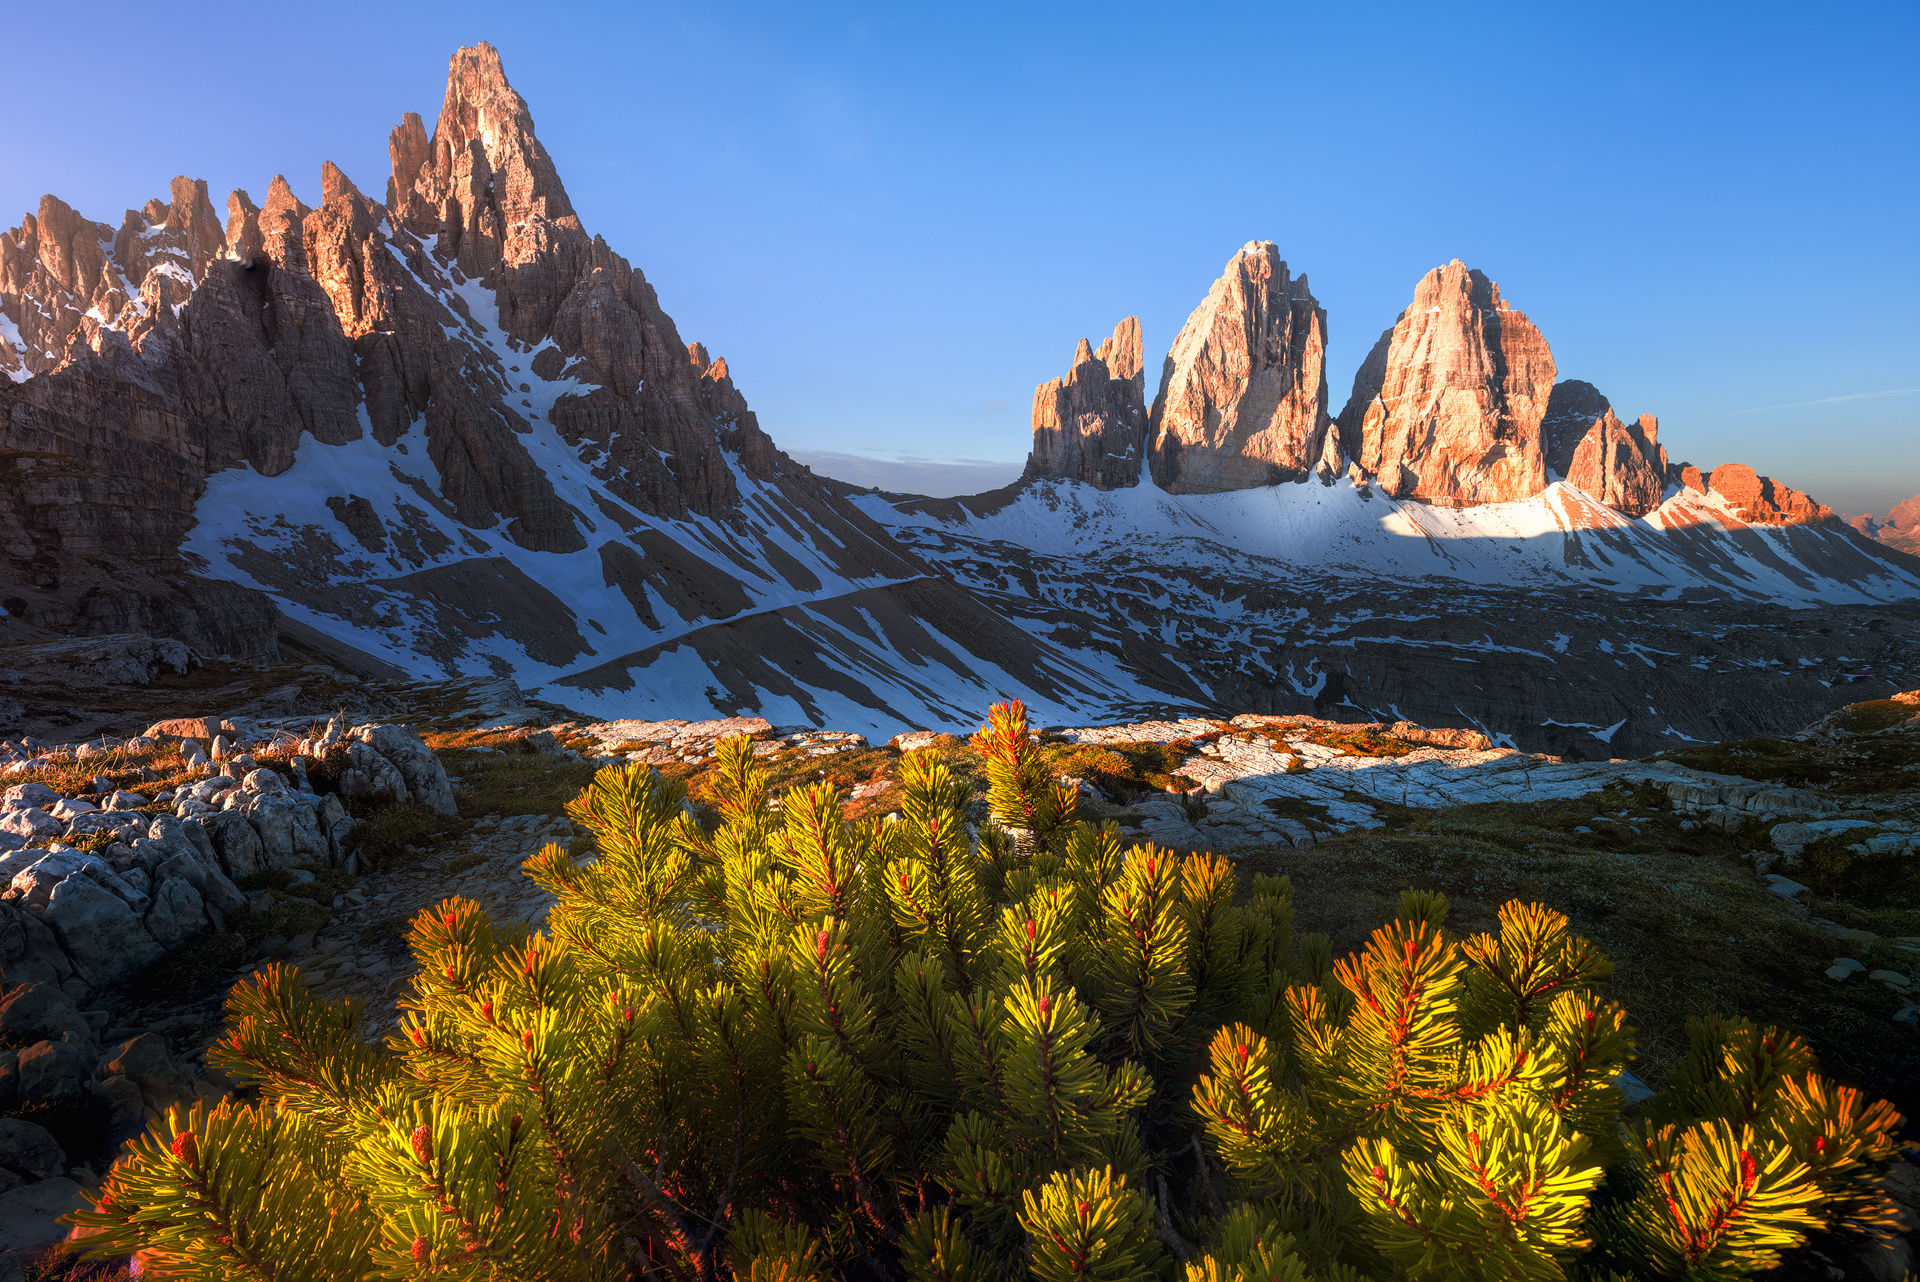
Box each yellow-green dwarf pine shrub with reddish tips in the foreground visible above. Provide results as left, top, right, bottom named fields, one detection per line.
left=63, top=704, right=1899, bottom=1282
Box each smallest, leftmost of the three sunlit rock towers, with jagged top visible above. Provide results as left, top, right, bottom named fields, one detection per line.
left=1021, top=317, right=1146, bottom=489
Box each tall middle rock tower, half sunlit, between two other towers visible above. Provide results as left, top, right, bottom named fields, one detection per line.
left=1148, top=240, right=1338, bottom=493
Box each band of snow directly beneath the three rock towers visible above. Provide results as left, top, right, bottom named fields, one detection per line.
left=856, top=480, right=1920, bottom=606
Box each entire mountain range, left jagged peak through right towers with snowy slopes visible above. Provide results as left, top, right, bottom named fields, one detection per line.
left=0, top=44, right=1920, bottom=756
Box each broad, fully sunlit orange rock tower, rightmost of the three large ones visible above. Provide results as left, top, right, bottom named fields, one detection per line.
left=1340, top=259, right=1553, bottom=507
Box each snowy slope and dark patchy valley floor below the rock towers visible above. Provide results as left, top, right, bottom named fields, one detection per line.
left=854, top=480, right=1920, bottom=758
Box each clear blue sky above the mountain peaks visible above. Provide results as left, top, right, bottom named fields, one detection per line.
left=0, top=0, right=1920, bottom=512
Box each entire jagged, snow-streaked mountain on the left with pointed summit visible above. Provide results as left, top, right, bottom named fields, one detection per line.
left=0, top=44, right=1139, bottom=725
